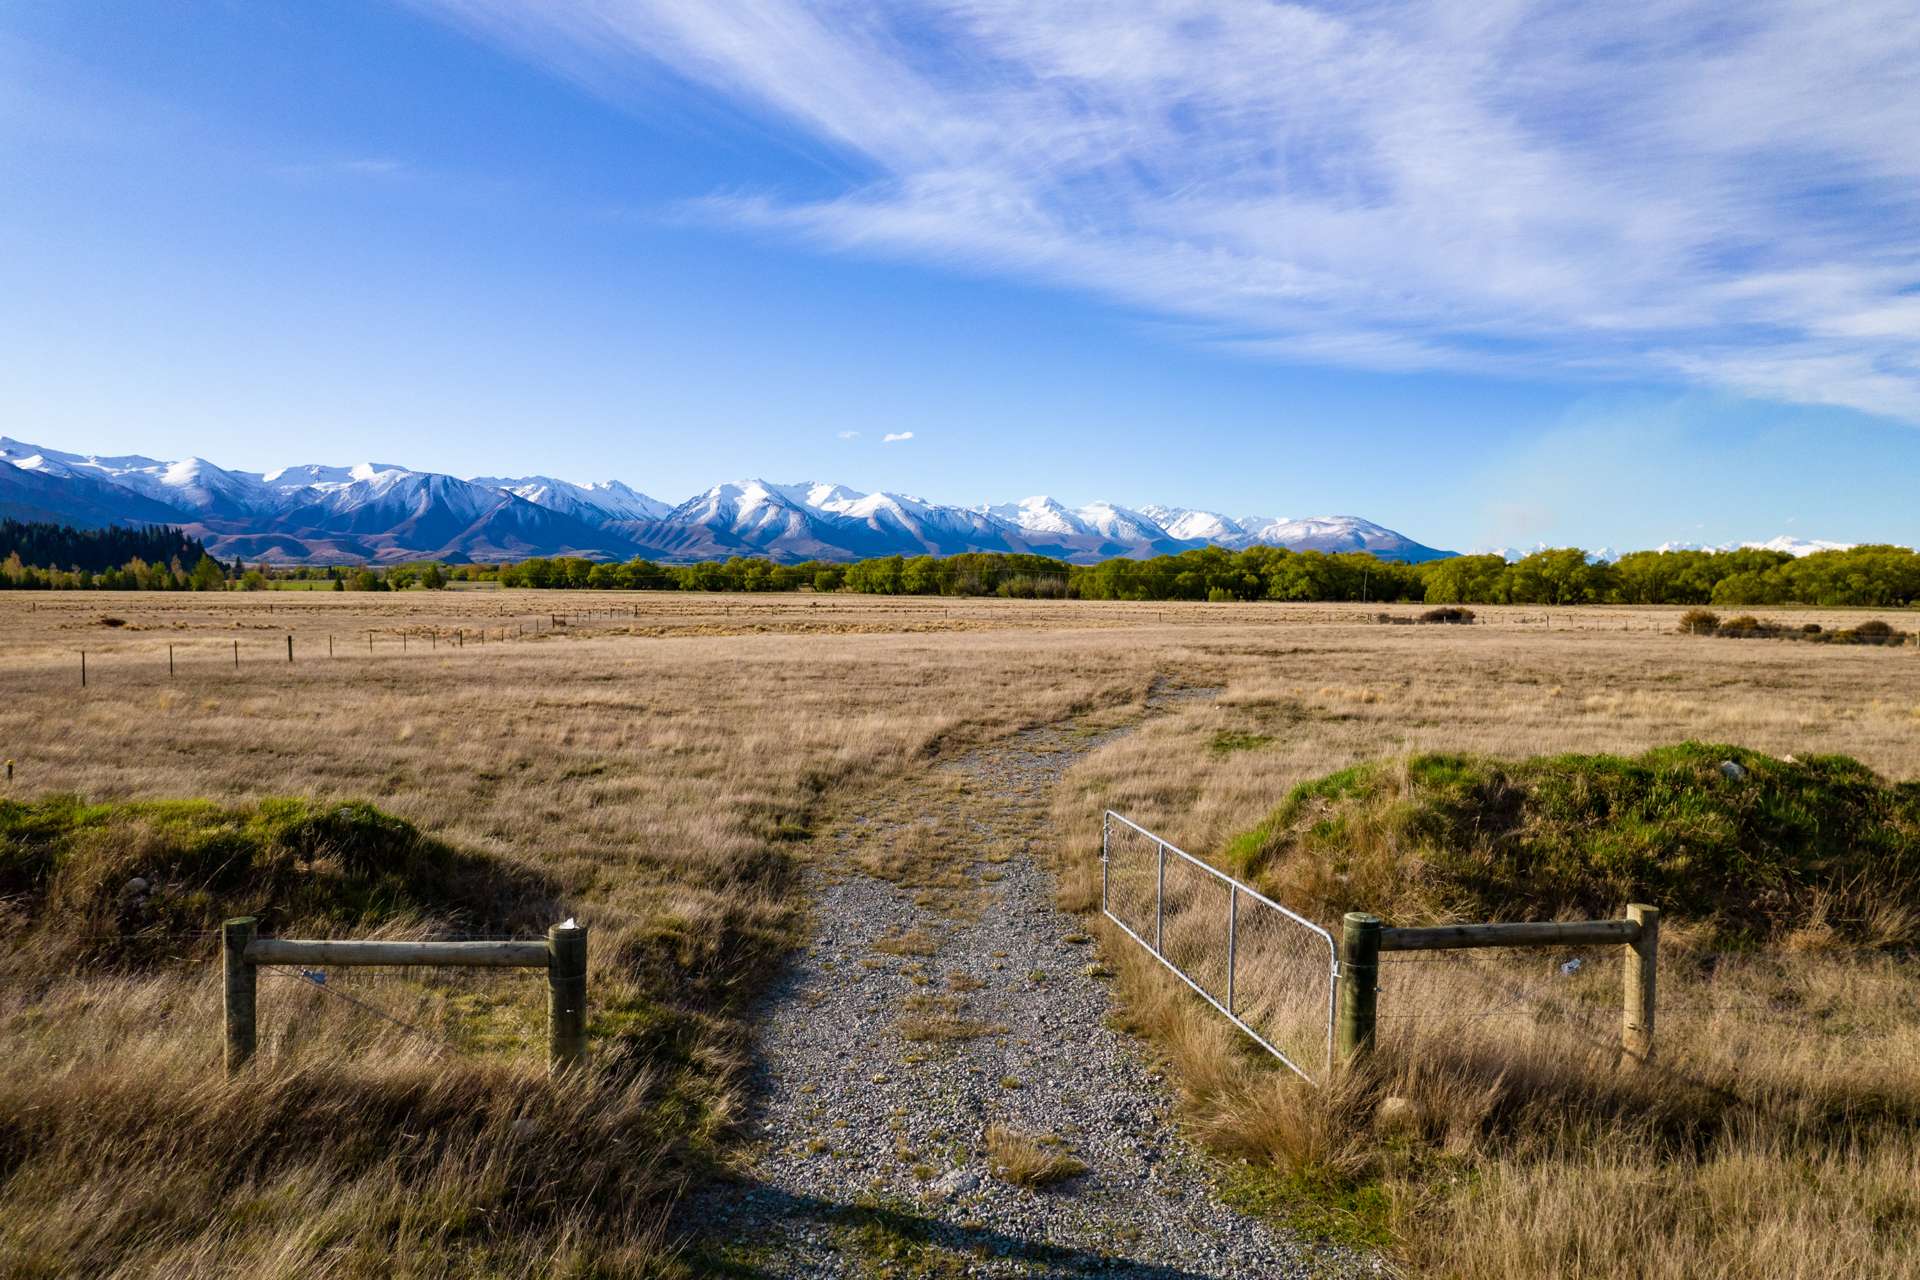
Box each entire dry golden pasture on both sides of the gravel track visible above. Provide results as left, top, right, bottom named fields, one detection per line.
left=0, top=591, right=1920, bottom=1276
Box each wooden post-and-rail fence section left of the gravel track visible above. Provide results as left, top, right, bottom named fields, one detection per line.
left=221, top=915, right=588, bottom=1075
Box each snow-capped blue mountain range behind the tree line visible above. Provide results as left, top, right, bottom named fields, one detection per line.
left=0, top=438, right=1452, bottom=562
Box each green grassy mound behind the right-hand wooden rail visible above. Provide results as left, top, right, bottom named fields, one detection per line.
left=1225, top=743, right=1920, bottom=944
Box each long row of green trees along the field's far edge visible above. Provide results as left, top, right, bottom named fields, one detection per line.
left=0, top=520, right=1920, bottom=608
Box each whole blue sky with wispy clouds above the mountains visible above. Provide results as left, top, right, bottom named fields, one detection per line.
left=0, top=0, right=1920, bottom=549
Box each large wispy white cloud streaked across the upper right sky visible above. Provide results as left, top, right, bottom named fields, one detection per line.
left=415, top=0, right=1920, bottom=420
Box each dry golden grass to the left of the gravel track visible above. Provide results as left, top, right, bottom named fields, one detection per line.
left=0, top=593, right=1152, bottom=1276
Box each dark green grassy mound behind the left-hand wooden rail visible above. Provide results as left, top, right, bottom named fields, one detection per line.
left=0, top=796, right=553, bottom=967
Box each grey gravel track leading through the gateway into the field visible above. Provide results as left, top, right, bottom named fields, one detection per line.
left=685, top=710, right=1357, bottom=1278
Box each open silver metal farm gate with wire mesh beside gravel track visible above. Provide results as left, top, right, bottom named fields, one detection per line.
left=1100, top=810, right=1338, bottom=1084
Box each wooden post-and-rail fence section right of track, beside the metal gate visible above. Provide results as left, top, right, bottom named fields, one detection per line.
left=1334, top=902, right=1661, bottom=1065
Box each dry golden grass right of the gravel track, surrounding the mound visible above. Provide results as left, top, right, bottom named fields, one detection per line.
left=1056, top=610, right=1920, bottom=1280
